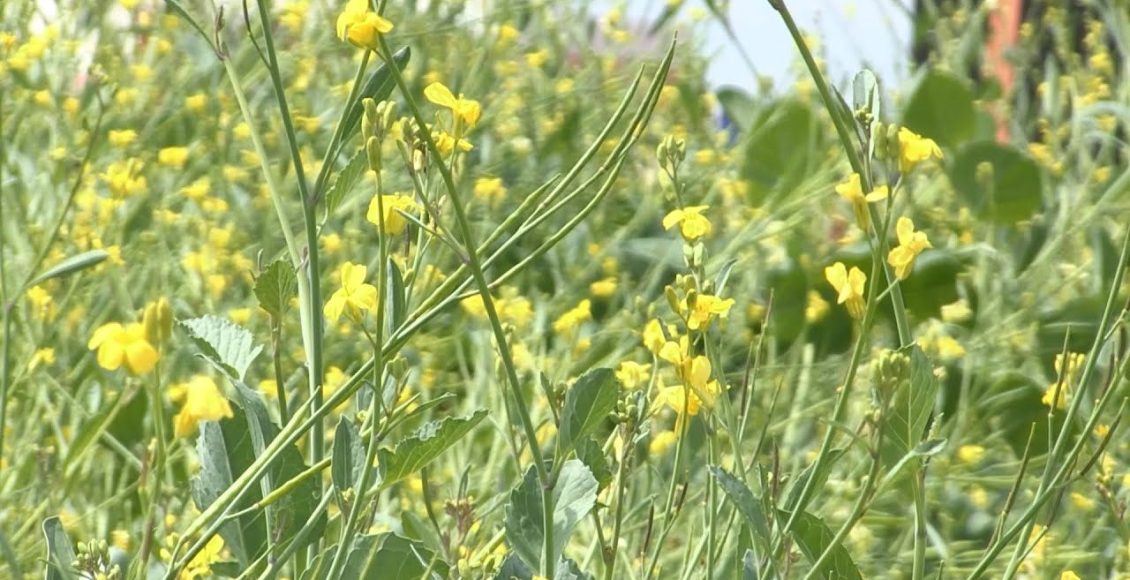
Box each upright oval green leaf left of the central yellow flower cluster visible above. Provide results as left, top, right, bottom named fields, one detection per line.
left=557, top=369, right=619, bottom=461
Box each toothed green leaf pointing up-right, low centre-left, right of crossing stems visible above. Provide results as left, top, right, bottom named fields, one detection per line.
left=376, top=409, right=487, bottom=487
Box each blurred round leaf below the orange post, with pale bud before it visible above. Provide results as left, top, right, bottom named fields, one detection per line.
left=949, top=141, right=1044, bottom=224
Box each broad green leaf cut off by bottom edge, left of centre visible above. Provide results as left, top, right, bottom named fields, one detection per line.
left=340, top=534, right=447, bottom=580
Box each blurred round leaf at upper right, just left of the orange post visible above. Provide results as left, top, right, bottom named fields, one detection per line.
left=903, top=70, right=976, bottom=147
